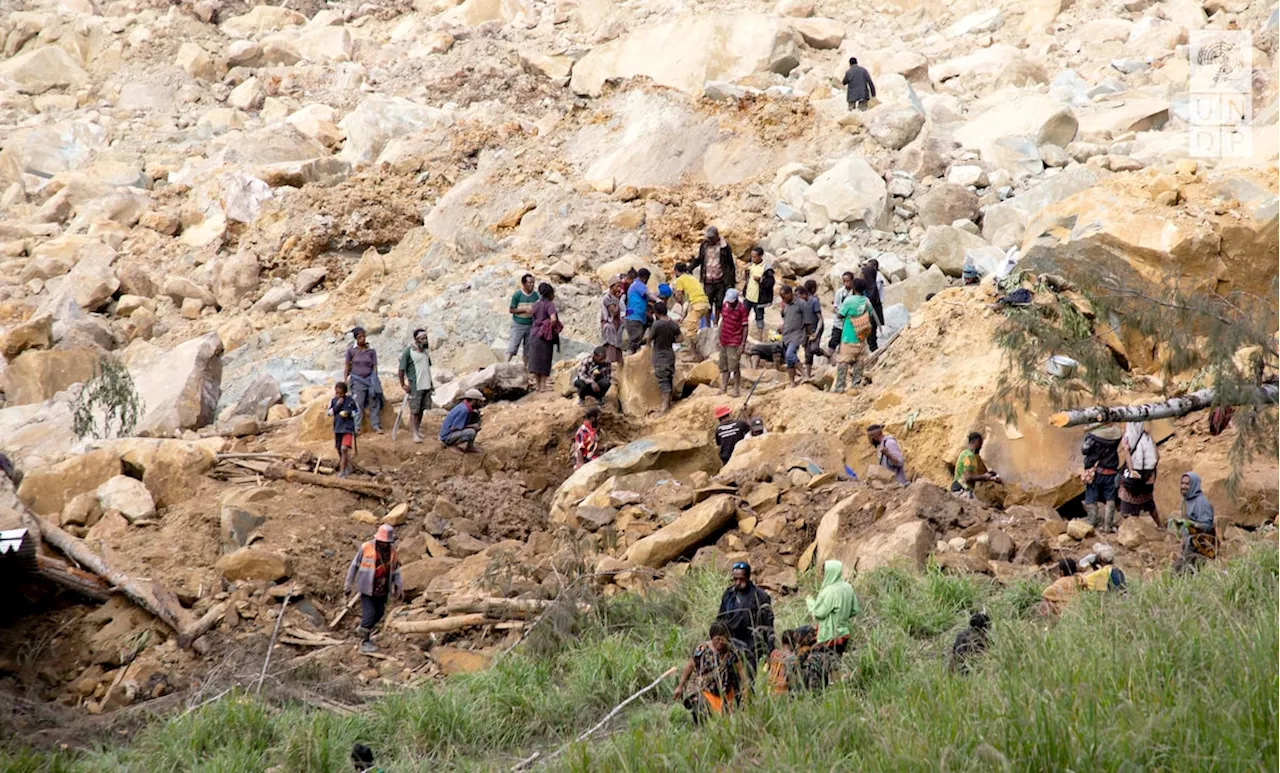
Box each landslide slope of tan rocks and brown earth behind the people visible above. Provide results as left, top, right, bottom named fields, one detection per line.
left=0, top=0, right=1280, bottom=726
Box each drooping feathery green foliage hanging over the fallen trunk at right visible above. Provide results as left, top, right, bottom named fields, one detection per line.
left=995, top=246, right=1280, bottom=488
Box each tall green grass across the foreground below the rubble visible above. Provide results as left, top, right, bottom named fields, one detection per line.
left=0, top=549, right=1280, bottom=773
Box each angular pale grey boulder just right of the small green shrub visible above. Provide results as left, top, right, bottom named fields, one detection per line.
left=125, top=333, right=223, bottom=438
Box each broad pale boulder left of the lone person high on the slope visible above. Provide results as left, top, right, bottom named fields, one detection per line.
left=570, top=12, right=800, bottom=96
